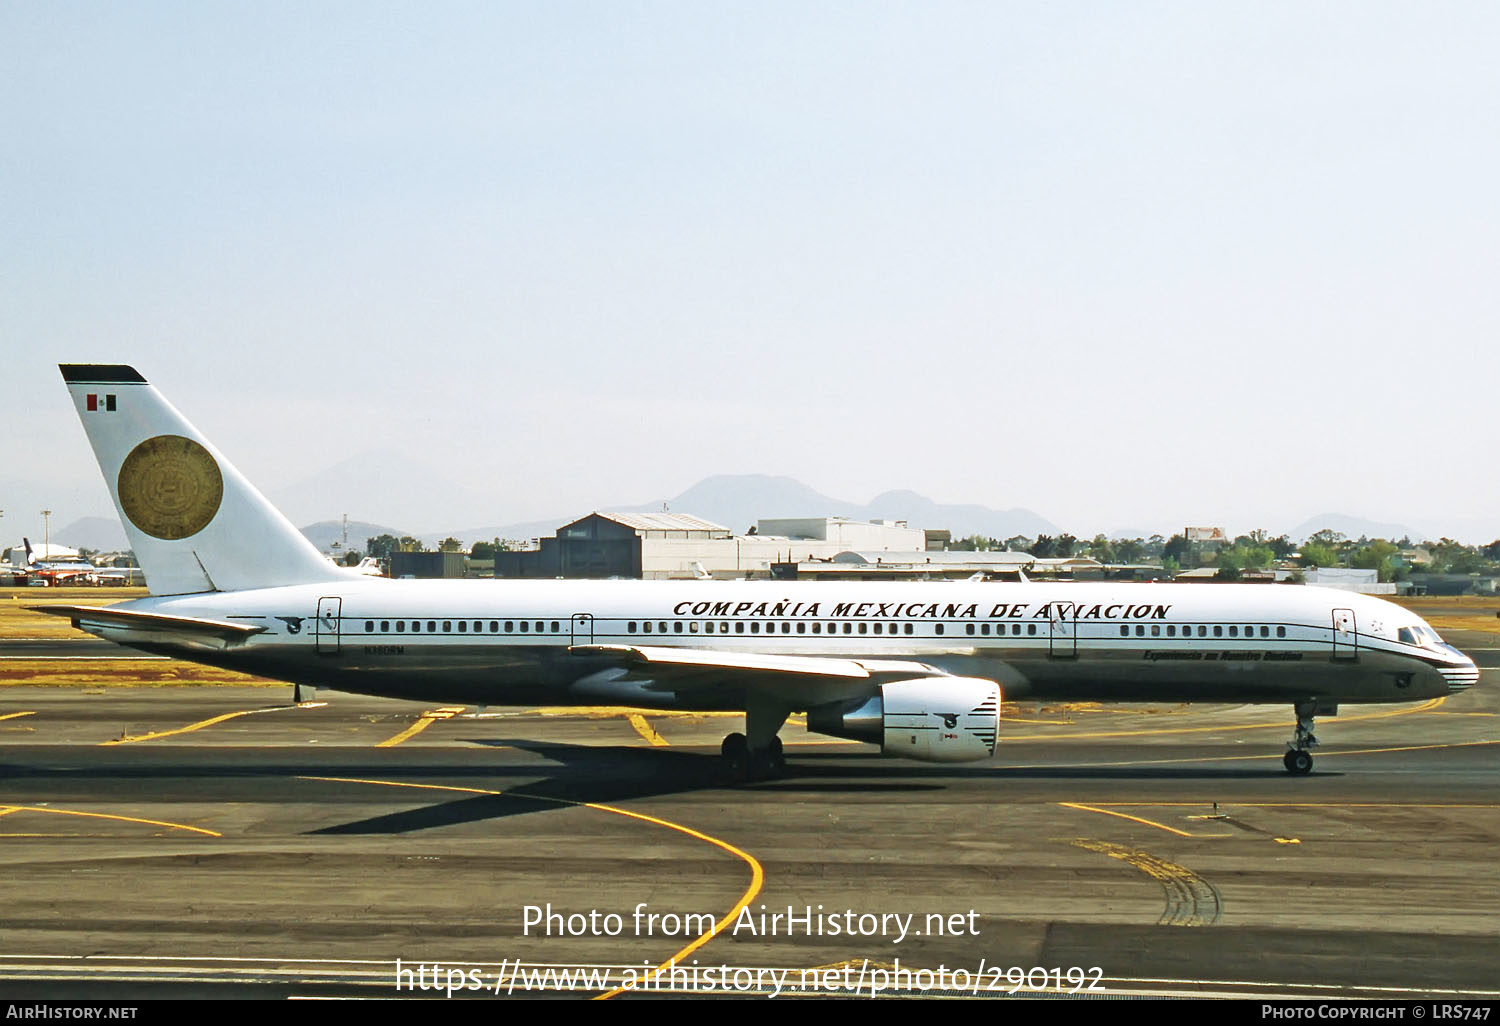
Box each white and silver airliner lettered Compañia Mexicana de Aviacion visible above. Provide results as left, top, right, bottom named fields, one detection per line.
left=42, top=365, right=1479, bottom=779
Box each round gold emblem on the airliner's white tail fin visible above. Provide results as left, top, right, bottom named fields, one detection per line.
left=119, top=435, right=224, bottom=542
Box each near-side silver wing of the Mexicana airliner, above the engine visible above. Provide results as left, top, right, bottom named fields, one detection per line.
left=569, top=645, right=948, bottom=708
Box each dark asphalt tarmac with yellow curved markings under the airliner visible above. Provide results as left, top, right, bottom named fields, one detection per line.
left=0, top=632, right=1500, bottom=1001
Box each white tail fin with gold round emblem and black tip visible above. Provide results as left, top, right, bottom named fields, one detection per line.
left=60, top=363, right=344, bottom=596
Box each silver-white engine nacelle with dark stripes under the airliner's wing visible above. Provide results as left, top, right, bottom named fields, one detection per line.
left=807, top=677, right=1001, bottom=762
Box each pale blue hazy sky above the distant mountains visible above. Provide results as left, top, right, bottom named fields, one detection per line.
left=0, top=0, right=1500, bottom=543
